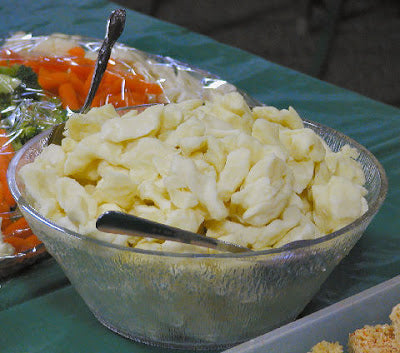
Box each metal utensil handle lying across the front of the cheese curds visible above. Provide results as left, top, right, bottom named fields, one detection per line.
left=96, top=211, right=251, bottom=253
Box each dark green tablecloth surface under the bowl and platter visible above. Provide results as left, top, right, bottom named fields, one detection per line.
left=0, top=0, right=400, bottom=353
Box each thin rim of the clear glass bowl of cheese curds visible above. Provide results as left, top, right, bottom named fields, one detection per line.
left=7, top=120, right=388, bottom=258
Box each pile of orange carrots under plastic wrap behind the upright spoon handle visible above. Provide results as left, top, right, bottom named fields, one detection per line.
left=0, top=46, right=163, bottom=110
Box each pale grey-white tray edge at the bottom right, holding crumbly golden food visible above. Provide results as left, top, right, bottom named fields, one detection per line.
left=224, top=275, right=400, bottom=353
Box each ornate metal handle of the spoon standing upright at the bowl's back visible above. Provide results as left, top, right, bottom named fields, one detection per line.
left=79, top=9, right=126, bottom=114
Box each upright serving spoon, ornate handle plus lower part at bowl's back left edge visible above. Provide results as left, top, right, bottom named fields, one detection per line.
left=47, top=9, right=126, bottom=145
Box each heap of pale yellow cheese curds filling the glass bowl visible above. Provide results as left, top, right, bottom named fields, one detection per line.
left=20, top=93, right=367, bottom=252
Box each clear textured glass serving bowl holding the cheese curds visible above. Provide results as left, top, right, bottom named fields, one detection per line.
left=8, top=122, right=387, bottom=349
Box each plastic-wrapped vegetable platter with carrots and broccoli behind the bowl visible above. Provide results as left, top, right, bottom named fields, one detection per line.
left=0, top=32, right=242, bottom=276
